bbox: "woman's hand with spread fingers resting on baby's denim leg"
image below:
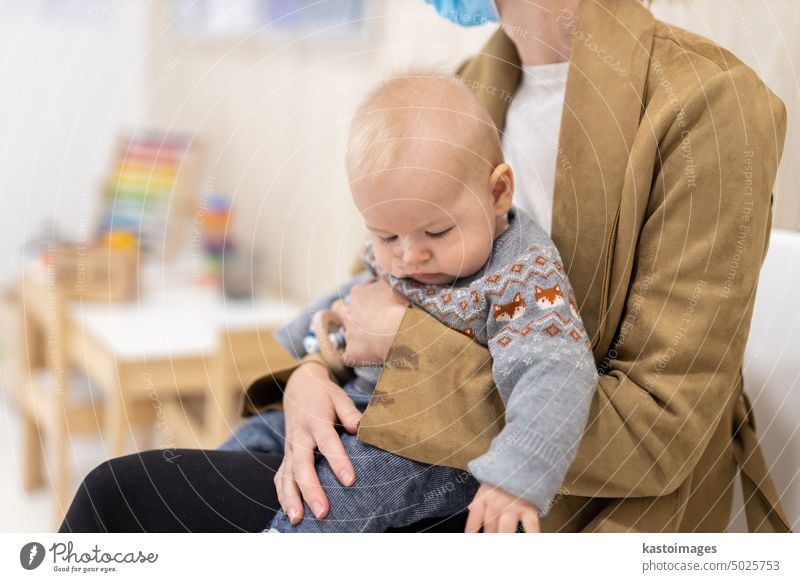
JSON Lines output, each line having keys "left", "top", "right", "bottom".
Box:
{"left": 275, "top": 362, "right": 361, "bottom": 524}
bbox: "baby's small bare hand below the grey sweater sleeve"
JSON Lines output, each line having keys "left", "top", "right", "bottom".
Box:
{"left": 465, "top": 483, "right": 539, "bottom": 533}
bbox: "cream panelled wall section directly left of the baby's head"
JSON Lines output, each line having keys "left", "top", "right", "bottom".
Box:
{"left": 145, "top": 0, "right": 491, "bottom": 299}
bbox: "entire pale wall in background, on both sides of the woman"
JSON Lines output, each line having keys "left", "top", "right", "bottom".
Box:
{"left": 0, "top": 0, "right": 800, "bottom": 299}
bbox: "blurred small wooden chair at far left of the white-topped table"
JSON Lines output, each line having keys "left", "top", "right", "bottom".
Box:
{"left": 16, "top": 276, "right": 153, "bottom": 524}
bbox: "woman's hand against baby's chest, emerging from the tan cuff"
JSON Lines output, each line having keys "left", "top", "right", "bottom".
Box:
{"left": 336, "top": 279, "right": 408, "bottom": 366}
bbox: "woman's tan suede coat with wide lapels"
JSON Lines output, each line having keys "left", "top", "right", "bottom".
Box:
{"left": 245, "top": 0, "right": 789, "bottom": 532}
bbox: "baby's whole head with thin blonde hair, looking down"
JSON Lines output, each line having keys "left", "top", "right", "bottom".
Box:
{"left": 347, "top": 73, "right": 514, "bottom": 284}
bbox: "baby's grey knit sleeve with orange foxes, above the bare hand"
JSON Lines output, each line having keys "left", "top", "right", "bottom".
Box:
{"left": 469, "top": 246, "right": 597, "bottom": 515}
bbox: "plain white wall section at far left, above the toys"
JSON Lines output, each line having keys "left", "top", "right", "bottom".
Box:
{"left": 0, "top": 0, "right": 150, "bottom": 285}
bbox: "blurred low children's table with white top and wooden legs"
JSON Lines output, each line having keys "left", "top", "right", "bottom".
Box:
{"left": 25, "top": 267, "right": 299, "bottom": 455}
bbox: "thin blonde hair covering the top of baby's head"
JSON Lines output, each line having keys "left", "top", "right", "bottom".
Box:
{"left": 347, "top": 69, "right": 503, "bottom": 186}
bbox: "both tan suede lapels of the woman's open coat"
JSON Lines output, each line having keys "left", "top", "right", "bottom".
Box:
{"left": 458, "top": 0, "right": 654, "bottom": 358}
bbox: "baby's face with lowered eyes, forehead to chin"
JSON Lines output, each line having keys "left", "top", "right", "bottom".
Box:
{"left": 351, "top": 155, "right": 510, "bottom": 285}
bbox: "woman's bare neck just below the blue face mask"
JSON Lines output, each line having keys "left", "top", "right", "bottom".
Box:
{"left": 497, "top": 0, "right": 580, "bottom": 66}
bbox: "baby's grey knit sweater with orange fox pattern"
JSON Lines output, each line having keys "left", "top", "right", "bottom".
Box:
{"left": 275, "top": 209, "right": 597, "bottom": 515}
